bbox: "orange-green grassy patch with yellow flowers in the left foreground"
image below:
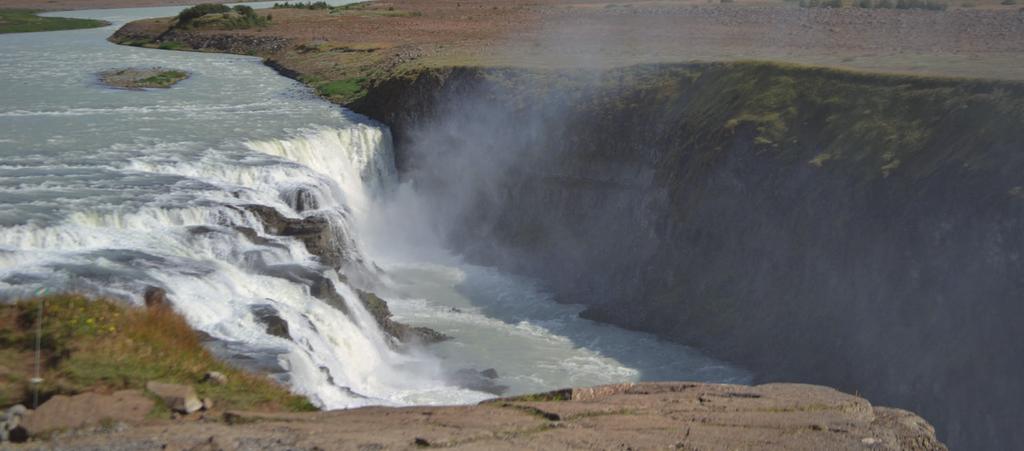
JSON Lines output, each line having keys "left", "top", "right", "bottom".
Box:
{"left": 0, "top": 295, "right": 315, "bottom": 414}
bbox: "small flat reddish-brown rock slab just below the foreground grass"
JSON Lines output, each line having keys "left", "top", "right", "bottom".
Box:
{"left": 22, "top": 390, "right": 154, "bottom": 436}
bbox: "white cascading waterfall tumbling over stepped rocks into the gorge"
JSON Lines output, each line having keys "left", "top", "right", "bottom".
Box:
{"left": 0, "top": 124, "right": 485, "bottom": 409}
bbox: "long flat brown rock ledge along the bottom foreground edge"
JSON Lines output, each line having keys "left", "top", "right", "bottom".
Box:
{"left": 30, "top": 382, "right": 946, "bottom": 450}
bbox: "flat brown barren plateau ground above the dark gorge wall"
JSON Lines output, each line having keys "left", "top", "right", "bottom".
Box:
{"left": 116, "top": 0, "right": 1024, "bottom": 80}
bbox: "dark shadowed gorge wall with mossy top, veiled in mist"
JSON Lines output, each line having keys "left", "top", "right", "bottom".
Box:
{"left": 352, "top": 64, "right": 1024, "bottom": 449}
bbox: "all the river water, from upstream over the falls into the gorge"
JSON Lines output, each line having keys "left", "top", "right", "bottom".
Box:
{"left": 0, "top": 2, "right": 748, "bottom": 408}
